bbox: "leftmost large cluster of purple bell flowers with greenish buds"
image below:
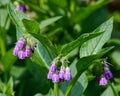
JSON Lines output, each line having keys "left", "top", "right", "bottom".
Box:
{"left": 13, "top": 37, "right": 34, "bottom": 59}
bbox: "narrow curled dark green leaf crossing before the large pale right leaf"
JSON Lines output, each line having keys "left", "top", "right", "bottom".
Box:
{"left": 61, "top": 31, "right": 102, "bottom": 55}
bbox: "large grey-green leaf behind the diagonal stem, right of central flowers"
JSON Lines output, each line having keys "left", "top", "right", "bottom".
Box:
{"left": 60, "top": 59, "right": 88, "bottom": 96}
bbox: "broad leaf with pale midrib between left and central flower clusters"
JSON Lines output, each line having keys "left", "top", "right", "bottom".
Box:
{"left": 31, "top": 42, "right": 55, "bottom": 79}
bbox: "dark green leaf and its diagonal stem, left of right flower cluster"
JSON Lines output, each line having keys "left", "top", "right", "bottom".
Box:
{"left": 65, "top": 47, "right": 113, "bottom": 96}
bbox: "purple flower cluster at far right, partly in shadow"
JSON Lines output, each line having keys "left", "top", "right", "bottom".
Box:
{"left": 97, "top": 64, "right": 113, "bottom": 85}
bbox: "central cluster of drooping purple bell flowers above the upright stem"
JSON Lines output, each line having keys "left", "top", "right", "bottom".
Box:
{"left": 47, "top": 61, "right": 72, "bottom": 83}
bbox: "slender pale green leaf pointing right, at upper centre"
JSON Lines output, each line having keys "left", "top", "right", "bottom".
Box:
{"left": 40, "top": 16, "right": 62, "bottom": 29}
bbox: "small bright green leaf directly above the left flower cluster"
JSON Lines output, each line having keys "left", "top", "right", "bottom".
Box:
{"left": 22, "top": 19, "right": 40, "bottom": 33}
